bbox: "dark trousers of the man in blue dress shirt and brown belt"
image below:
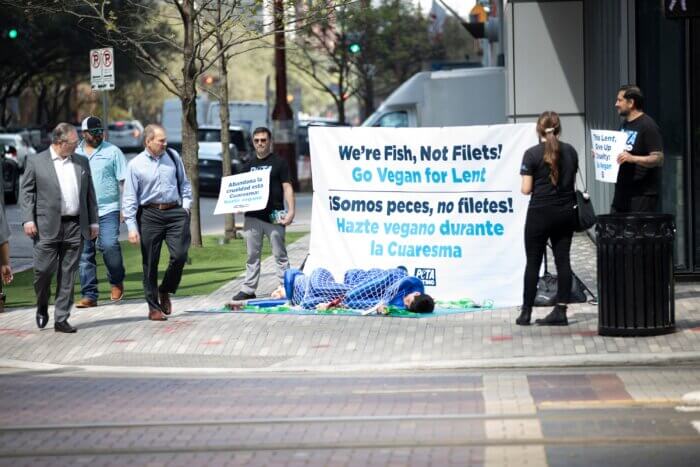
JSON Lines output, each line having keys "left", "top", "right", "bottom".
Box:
{"left": 137, "top": 206, "right": 191, "bottom": 311}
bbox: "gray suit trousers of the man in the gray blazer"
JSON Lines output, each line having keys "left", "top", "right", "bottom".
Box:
{"left": 34, "top": 216, "right": 83, "bottom": 323}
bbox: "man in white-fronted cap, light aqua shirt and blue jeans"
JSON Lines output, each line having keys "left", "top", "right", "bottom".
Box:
{"left": 75, "top": 117, "right": 126, "bottom": 308}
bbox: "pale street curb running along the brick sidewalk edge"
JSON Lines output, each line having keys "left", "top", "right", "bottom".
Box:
{"left": 0, "top": 352, "right": 700, "bottom": 375}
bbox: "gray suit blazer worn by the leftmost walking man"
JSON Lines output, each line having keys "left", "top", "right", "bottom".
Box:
{"left": 20, "top": 149, "right": 99, "bottom": 240}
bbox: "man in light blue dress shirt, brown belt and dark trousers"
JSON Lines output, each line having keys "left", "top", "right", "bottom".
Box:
{"left": 122, "top": 124, "right": 192, "bottom": 321}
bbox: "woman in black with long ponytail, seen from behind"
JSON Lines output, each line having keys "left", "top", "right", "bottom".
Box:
{"left": 515, "top": 111, "right": 578, "bottom": 326}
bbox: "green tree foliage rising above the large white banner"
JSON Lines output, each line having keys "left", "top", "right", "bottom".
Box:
{"left": 290, "top": 0, "right": 445, "bottom": 122}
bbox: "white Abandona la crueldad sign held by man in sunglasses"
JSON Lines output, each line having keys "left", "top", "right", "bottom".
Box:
{"left": 214, "top": 167, "right": 270, "bottom": 214}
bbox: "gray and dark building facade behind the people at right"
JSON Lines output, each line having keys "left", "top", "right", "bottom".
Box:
{"left": 503, "top": 0, "right": 700, "bottom": 278}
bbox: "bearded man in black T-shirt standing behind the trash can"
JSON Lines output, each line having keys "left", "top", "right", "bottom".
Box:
{"left": 611, "top": 85, "right": 664, "bottom": 213}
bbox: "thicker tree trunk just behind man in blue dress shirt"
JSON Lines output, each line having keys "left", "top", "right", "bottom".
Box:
{"left": 182, "top": 0, "right": 202, "bottom": 247}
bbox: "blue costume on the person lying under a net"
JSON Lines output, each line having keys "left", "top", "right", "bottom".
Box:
{"left": 284, "top": 267, "right": 425, "bottom": 310}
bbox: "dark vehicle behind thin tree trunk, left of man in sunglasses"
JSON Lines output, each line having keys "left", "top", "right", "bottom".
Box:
{"left": 197, "top": 125, "right": 253, "bottom": 194}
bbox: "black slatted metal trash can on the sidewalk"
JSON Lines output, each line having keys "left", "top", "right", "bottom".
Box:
{"left": 596, "top": 213, "right": 676, "bottom": 336}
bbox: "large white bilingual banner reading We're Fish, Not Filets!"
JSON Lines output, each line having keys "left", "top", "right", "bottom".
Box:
{"left": 305, "top": 123, "right": 537, "bottom": 307}
